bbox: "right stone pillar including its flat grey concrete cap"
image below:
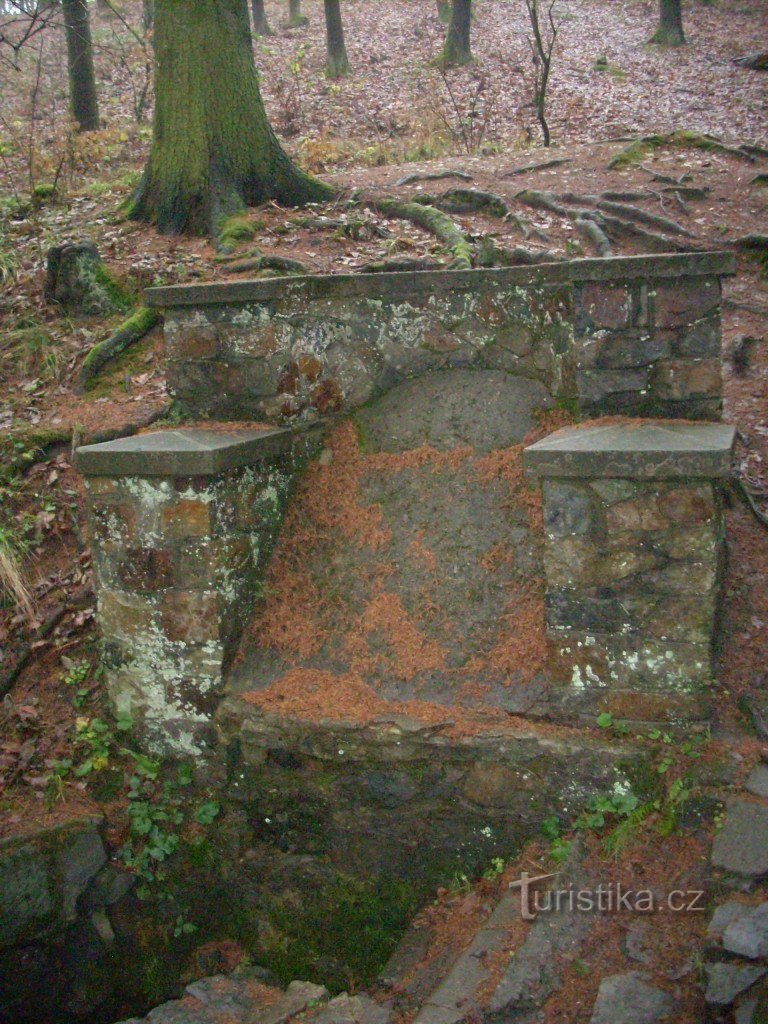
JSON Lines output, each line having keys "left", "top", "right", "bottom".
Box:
{"left": 524, "top": 420, "right": 734, "bottom": 724}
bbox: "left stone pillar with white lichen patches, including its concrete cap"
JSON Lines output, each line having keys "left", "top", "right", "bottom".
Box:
{"left": 78, "top": 429, "right": 321, "bottom": 755}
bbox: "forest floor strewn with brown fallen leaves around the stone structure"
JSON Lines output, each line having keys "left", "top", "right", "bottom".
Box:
{"left": 0, "top": 0, "right": 768, "bottom": 1020}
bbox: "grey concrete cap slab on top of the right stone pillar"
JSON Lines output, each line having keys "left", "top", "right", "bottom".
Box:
{"left": 523, "top": 420, "right": 736, "bottom": 480}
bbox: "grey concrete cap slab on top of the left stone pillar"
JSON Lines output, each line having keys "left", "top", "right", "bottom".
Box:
{"left": 75, "top": 427, "right": 307, "bottom": 477}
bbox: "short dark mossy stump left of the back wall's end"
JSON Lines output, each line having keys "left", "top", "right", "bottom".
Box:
{"left": 45, "top": 241, "right": 127, "bottom": 316}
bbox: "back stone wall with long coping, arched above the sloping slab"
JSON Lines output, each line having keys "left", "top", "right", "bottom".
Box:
{"left": 146, "top": 253, "right": 734, "bottom": 421}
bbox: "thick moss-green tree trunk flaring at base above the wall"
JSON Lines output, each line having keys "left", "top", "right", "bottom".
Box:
{"left": 127, "top": 0, "right": 333, "bottom": 234}
